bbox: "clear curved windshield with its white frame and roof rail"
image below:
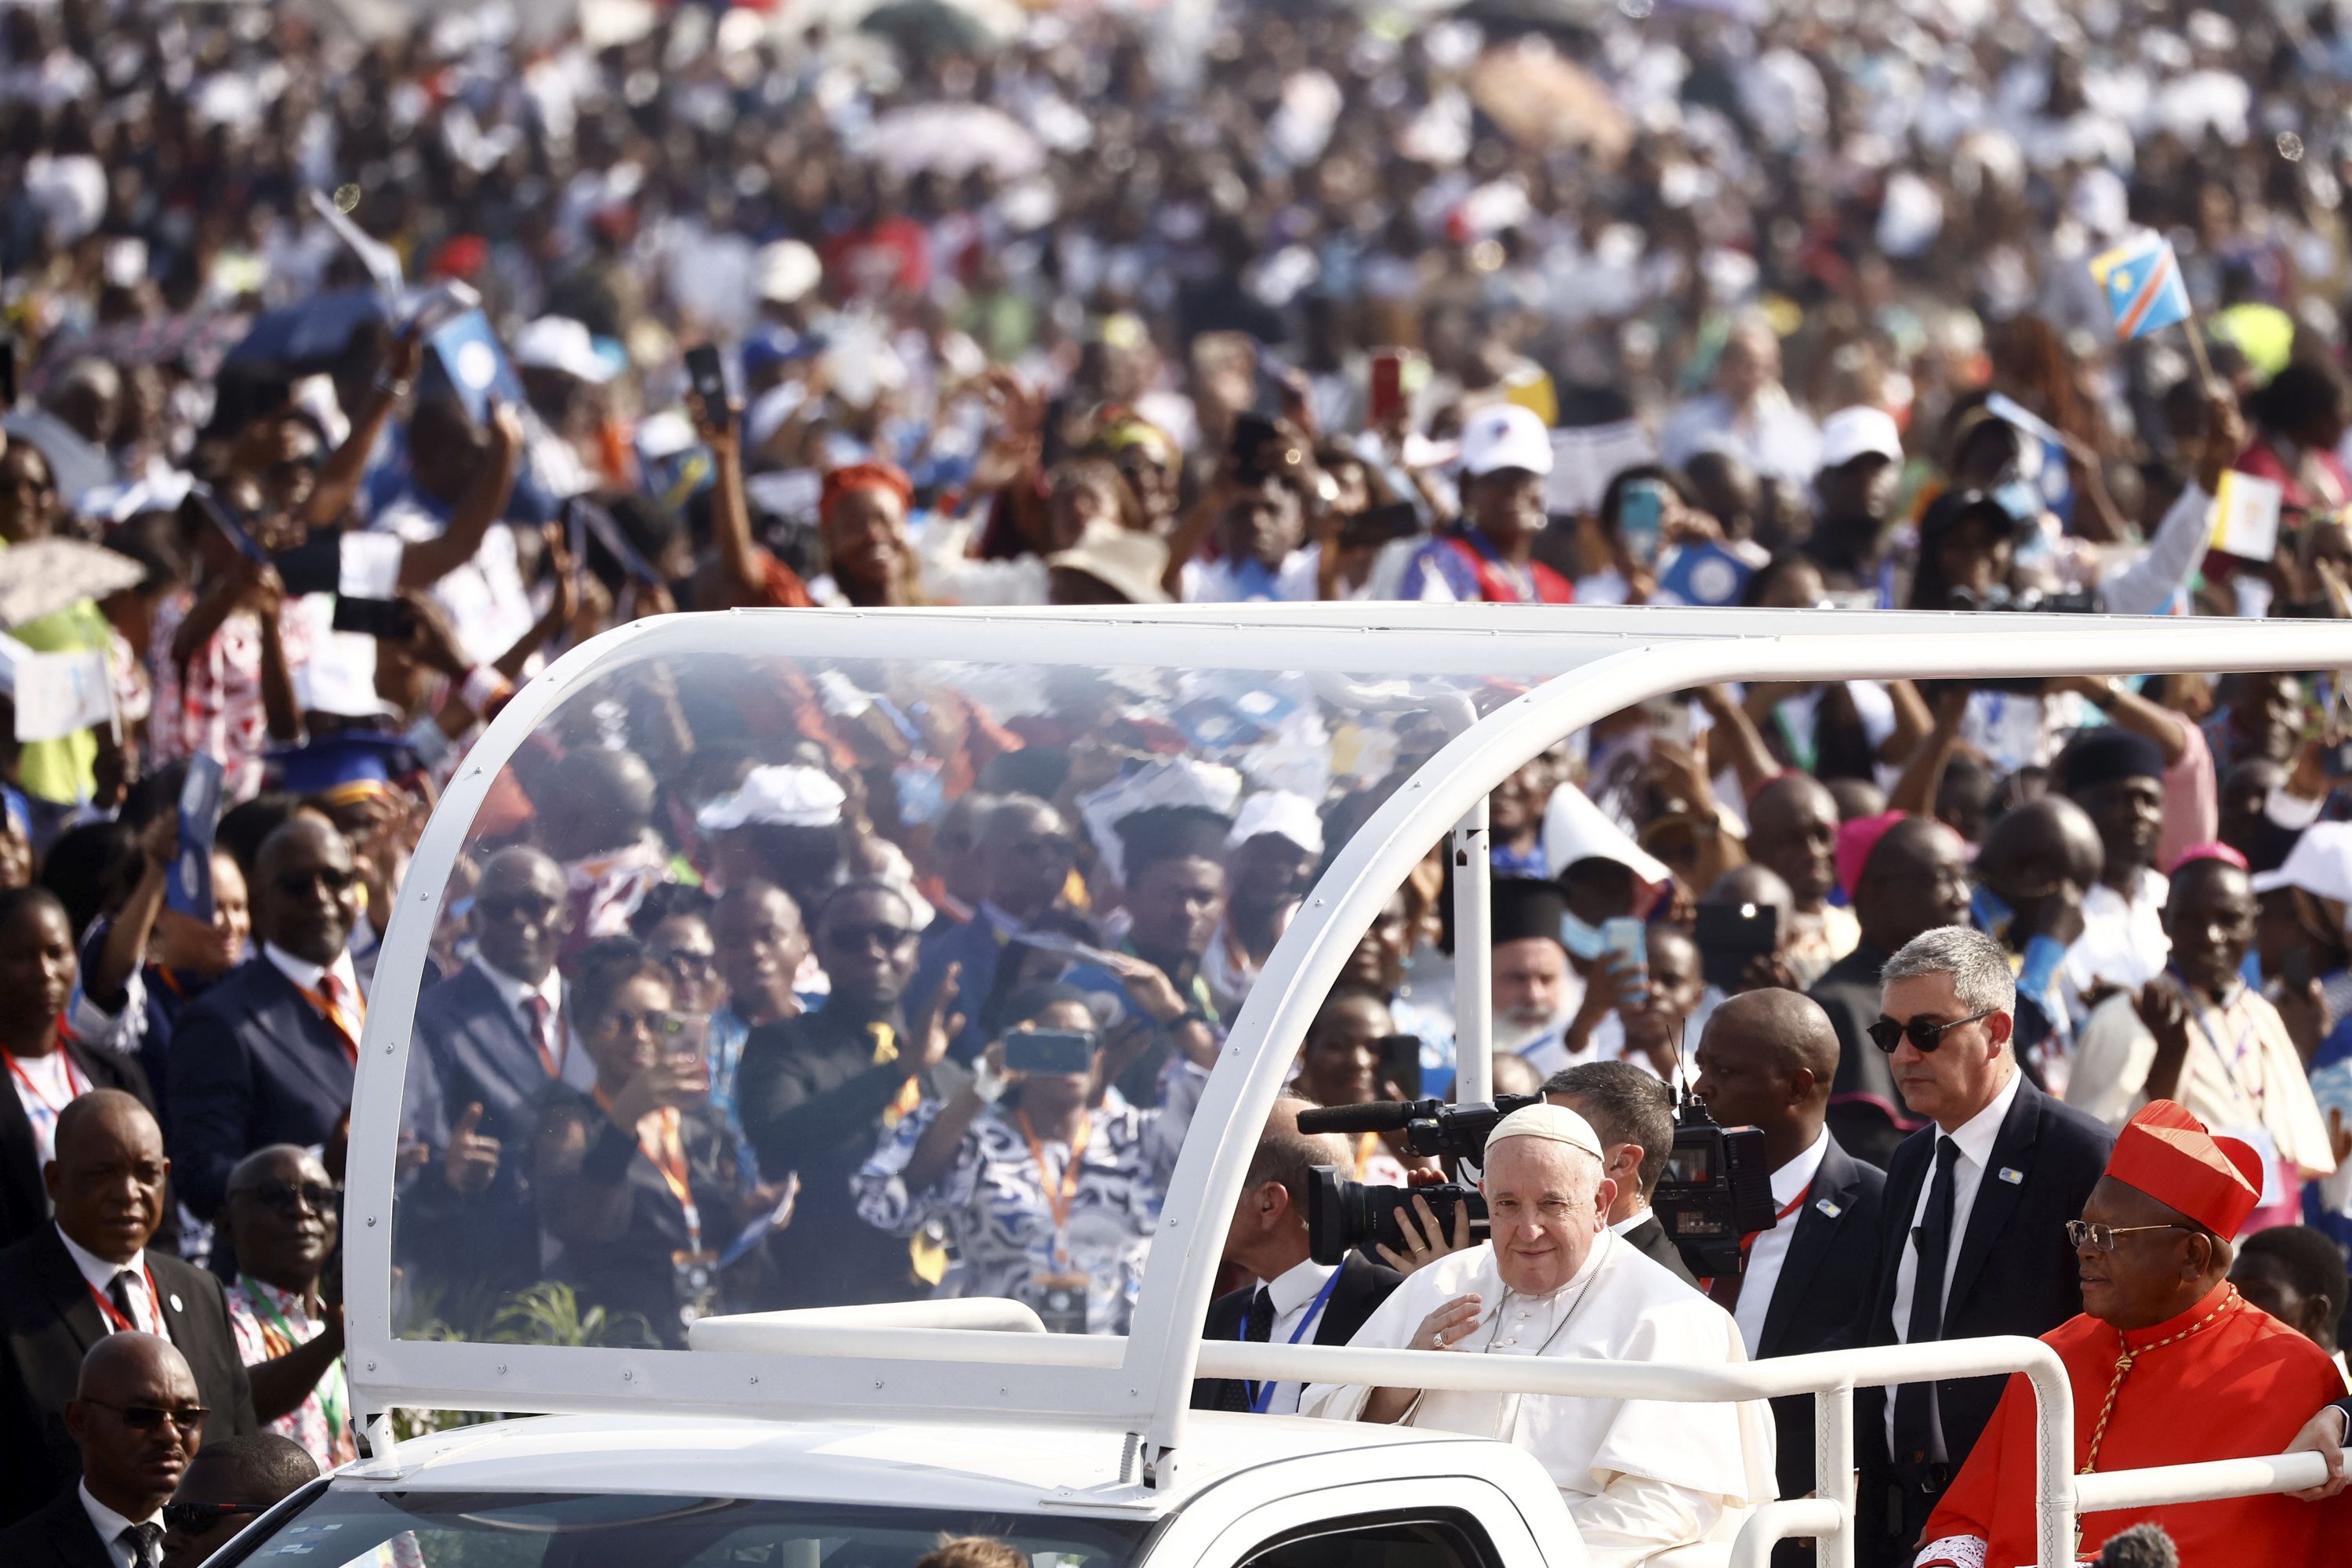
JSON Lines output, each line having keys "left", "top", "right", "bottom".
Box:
{"left": 343, "top": 604, "right": 2352, "bottom": 1446}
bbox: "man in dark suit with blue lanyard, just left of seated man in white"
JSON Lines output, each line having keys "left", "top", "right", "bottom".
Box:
{"left": 1192, "top": 1100, "right": 1404, "bottom": 1415}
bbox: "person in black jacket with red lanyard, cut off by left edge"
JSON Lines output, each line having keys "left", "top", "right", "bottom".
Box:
{"left": 0, "top": 886, "right": 169, "bottom": 1246}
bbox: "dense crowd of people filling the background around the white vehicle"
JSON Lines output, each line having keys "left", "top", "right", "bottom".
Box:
{"left": 0, "top": 0, "right": 2352, "bottom": 1566}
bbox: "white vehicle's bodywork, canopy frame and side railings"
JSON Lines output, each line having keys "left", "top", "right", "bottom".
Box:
{"left": 214, "top": 604, "right": 2352, "bottom": 1568}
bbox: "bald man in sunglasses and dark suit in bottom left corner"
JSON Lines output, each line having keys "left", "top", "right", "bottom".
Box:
{"left": 0, "top": 1333, "right": 207, "bottom": 1568}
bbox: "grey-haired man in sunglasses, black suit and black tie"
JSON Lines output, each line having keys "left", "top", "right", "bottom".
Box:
{"left": 1853, "top": 926, "right": 2114, "bottom": 1566}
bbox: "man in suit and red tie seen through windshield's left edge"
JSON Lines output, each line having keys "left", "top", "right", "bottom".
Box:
{"left": 400, "top": 846, "right": 576, "bottom": 1286}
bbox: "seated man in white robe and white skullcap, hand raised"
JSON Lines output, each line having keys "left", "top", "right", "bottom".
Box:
{"left": 1298, "top": 1105, "right": 1773, "bottom": 1568}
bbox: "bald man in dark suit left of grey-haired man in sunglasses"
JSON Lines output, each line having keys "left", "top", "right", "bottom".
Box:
{"left": 1691, "top": 989, "right": 1886, "bottom": 1568}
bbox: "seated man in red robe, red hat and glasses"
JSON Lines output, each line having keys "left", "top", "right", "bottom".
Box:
{"left": 1915, "top": 1100, "right": 2352, "bottom": 1568}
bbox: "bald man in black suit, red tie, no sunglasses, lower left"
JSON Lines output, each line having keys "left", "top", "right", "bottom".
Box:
{"left": 0, "top": 1088, "right": 254, "bottom": 1521}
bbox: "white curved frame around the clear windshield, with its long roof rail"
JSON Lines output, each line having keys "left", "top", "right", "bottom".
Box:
{"left": 346, "top": 604, "right": 2352, "bottom": 1542}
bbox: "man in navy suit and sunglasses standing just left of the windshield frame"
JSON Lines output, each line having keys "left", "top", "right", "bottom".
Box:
{"left": 169, "top": 811, "right": 365, "bottom": 1220}
